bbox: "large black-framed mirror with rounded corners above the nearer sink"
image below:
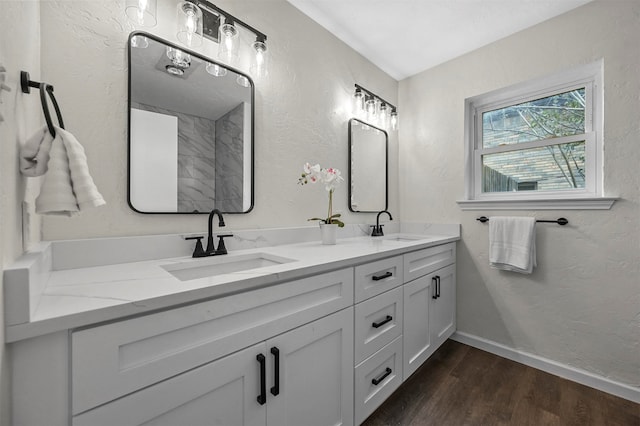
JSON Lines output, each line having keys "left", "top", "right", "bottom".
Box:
{"left": 128, "top": 32, "right": 254, "bottom": 213}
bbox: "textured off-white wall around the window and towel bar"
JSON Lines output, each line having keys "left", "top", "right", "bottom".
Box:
{"left": 399, "top": 1, "right": 640, "bottom": 386}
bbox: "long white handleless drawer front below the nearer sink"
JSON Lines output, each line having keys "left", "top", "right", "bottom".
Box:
{"left": 71, "top": 268, "right": 353, "bottom": 414}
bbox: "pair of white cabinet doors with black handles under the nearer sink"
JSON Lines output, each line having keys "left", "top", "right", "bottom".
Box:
{"left": 73, "top": 308, "right": 353, "bottom": 426}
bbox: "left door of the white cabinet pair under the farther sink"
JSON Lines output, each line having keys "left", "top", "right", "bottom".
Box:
{"left": 403, "top": 275, "right": 435, "bottom": 380}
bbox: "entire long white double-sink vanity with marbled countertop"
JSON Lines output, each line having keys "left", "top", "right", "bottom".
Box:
{"left": 5, "top": 226, "right": 459, "bottom": 426}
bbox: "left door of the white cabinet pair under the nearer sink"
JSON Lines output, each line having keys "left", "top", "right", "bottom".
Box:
{"left": 72, "top": 342, "right": 266, "bottom": 426}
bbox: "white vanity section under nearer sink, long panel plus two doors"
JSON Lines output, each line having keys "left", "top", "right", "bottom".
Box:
{"left": 71, "top": 268, "right": 353, "bottom": 426}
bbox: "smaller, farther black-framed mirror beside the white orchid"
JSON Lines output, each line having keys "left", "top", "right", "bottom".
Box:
{"left": 349, "top": 118, "right": 389, "bottom": 213}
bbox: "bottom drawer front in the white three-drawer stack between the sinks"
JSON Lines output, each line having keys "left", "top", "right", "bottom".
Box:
{"left": 355, "top": 336, "right": 402, "bottom": 425}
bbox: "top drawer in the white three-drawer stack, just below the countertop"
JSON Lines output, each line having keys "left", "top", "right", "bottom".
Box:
{"left": 355, "top": 256, "right": 403, "bottom": 303}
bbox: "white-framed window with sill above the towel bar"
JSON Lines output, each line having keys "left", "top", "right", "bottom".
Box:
{"left": 459, "top": 62, "right": 612, "bottom": 209}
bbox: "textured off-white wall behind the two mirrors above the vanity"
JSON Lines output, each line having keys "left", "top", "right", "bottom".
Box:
{"left": 42, "top": 0, "right": 398, "bottom": 240}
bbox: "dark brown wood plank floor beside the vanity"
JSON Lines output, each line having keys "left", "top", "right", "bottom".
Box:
{"left": 363, "top": 340, "right": 640, "bottom": 426}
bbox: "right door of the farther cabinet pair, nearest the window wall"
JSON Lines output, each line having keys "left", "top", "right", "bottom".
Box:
{"left": 431, "top": 265, "right": 456, "bottom": 348}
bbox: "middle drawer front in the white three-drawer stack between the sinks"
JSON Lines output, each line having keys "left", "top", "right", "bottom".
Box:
{"left": 355, "top": 287, "right": 403, "bottom": 364}
